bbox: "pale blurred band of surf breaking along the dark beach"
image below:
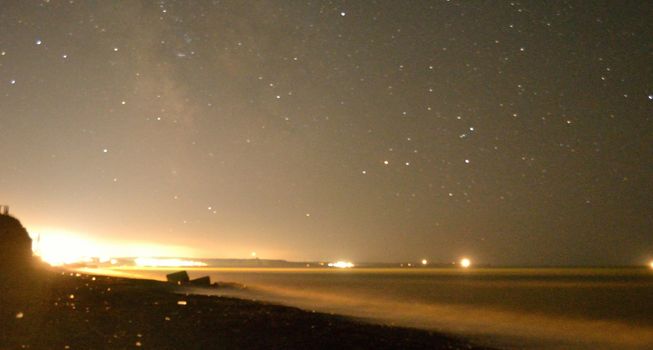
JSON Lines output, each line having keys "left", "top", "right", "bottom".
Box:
{"left": 194, "top": 284, "right": 653, "bottom": 349}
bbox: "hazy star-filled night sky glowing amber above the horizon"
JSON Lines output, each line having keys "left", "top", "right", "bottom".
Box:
{"left": 0, "top": 0, "right": 653, "bottom": 265}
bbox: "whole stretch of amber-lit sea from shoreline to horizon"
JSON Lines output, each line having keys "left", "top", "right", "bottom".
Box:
{"left": 91, "top": 268, "right": 653, "bottom": 349}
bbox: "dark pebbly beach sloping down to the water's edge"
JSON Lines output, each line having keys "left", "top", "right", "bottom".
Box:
{"left": 0, "top": 272, "right": 488, "bottom": 349}
